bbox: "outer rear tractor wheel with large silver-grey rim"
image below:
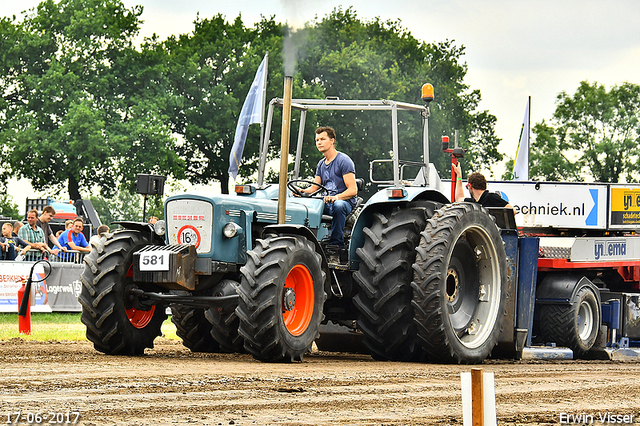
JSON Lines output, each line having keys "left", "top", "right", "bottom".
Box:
{"left": 411, "top": 203, "right": 507, "bottom": 364}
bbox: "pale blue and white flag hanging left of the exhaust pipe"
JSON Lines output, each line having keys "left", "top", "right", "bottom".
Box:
{"left": 229, "top": 53, "right": 269, "bottom": 180}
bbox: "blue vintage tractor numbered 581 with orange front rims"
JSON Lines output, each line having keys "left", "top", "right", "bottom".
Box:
{"left": 80, "top": 90, "right": 510, "bottom": 363}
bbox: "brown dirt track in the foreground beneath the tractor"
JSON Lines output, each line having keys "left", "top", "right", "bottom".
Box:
{"left": 0, "top": 338, "right": 640, "bottom": 425}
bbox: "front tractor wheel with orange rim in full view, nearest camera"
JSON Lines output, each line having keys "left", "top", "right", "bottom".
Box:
{"left": 236, "top": 235, "right": 326, "bottom": 362}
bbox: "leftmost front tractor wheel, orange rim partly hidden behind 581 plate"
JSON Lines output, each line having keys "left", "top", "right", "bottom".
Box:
{"left": 78, "top": 229, "right": 167, "bottom": 355}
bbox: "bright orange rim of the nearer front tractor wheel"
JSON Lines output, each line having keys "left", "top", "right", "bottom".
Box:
{"left": 282, "top": 265, "right": 315, "bottom": 336}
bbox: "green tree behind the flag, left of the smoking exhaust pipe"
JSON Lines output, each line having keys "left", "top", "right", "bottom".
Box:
{"left": 162, "top": 15, "right": 318, "bottom": 192}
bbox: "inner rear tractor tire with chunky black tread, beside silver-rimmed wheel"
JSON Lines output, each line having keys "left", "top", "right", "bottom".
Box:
{"left": 354, "top": 202, "right": 440, "bottom": 361}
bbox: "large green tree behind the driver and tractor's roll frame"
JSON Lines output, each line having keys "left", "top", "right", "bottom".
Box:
{"left": 296, "top": 8, "right": 502, "bottom": 189}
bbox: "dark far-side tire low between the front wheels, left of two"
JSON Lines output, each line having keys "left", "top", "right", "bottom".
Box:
{"left": 171, "top": 306, "right": 220, "bottom": 353}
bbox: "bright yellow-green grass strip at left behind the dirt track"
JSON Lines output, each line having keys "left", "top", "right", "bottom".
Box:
{"left": 0, "top": 312, "right": 180, "bottom": 342}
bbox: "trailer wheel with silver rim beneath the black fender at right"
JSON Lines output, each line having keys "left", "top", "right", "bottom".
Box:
{"left": 540, "top": 286, "right": 601, "bottom": 358}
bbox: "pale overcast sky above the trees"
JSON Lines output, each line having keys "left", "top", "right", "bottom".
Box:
{"left": 0, "top": 0, "right": 640, "bottom": 206}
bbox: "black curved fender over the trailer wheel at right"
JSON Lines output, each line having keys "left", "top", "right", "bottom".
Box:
{"left": 536, "top": 274, "right": 600, "bottom": 305}
